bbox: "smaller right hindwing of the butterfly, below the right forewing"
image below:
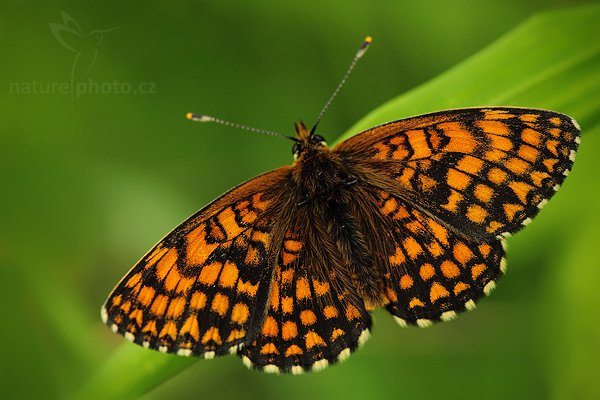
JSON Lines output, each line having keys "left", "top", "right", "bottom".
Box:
{"left": 378, "top": 192, "right": 506, "bottom": 327}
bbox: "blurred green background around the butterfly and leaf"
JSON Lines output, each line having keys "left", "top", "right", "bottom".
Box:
{"left": 0, "top": 0, "right": 600, "bottom": 399}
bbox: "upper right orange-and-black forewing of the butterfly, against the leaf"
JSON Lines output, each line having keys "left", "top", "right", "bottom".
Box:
{"left": 335, "top": 107, "right": 580, "bottom": 240}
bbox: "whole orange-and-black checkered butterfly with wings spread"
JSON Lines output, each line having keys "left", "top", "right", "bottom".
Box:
{"left": 102, "top": 38, "right": 580, "bottom": 374}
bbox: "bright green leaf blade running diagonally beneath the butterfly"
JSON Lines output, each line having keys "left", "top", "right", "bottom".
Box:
{"left": 79, "top": 4, "right": 600, "bottom": 399}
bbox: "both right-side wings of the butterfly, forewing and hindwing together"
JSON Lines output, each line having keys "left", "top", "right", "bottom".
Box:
{"left": 335, "top": 108, "right": 580, "bottom": 326}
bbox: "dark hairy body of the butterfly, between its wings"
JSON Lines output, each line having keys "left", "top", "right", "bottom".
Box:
{"left": 290, "top": 124, "right": 392, "bottom": 309}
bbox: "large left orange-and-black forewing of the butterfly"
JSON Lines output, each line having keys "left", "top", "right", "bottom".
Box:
{"left": 102, "top": 167, "right": 291, "bottom": 358}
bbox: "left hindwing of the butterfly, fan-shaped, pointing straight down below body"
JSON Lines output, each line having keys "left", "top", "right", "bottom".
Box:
{"left": 238, "top": 207, "right": 371, "bottom": 374}
